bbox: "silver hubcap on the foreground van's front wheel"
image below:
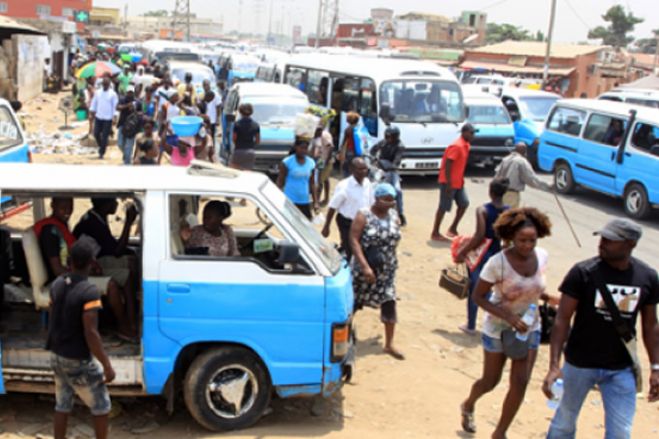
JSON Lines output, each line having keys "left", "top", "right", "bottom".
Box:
{"left": 206, "top": 364, "right": 259, "bottom": 419}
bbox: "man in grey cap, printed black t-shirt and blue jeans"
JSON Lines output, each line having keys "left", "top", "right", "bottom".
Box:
{"left": 543, "top": 219, "right": 659, "bottom": 439}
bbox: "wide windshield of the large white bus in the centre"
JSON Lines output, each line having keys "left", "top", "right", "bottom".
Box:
{"left": 380, "top": 79, "right": 465, "bottom": 123}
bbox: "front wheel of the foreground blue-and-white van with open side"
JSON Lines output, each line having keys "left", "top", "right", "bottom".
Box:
{"left": 183, "top": 347, "right": 272, "bottom": 431}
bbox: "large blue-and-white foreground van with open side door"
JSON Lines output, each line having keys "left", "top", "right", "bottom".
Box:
{"left": 0, "top": 162, "right": 353, "bottom": 430}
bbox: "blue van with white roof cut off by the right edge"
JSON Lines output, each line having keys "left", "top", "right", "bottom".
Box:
{"left": 538, "top": 99, "right": 659, "bottom": 219}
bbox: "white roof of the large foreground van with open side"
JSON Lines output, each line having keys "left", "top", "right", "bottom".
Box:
{"left": 0, "top": 161, "right": 268, "bottom": 193}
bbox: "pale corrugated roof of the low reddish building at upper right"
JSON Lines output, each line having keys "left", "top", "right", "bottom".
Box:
{"left": 468, "top": 40, "right": 608, "bottom": 58}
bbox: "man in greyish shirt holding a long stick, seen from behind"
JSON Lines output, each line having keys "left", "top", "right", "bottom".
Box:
{"left": 495, "top": 142, "right": 551, "bottom": 208}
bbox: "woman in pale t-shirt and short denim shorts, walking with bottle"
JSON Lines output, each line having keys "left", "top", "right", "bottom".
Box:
{"left": 460, "top": 208, "right": 551, "bottom": 439}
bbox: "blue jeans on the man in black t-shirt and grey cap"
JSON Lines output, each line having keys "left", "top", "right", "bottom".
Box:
{"left": 547, "top": 362, "right": 636, "bottom": 439}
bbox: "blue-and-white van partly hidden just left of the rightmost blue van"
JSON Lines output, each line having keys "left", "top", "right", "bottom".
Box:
{"left": 501, "top": 87, "right": 561, "bottom": 165}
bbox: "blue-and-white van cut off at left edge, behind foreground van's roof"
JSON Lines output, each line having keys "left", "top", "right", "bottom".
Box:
{"left": 0, "top": 99, "right": 31, "bottom": 216}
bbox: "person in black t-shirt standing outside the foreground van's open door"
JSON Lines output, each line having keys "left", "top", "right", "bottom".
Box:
{"left": 46, "top": 241, "right": 115, "bottom": 439}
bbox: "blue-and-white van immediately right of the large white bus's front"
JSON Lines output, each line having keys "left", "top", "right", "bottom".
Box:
{"left": 463, "top": 88, "right": 515, "bottom": 164}
